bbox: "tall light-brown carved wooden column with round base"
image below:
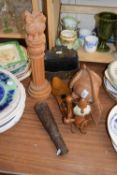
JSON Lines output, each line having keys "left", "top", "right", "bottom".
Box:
{"left": 25, "top": 11, "right": 51, "bottom": 101}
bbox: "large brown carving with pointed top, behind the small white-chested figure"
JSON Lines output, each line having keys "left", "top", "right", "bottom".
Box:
{"left": 70, "top": 65, "right": 102, "bottom": 124}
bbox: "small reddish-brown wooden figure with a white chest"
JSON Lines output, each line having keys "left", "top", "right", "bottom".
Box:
{"left": 64, "top": 90, "right": 92, "bottom": 133}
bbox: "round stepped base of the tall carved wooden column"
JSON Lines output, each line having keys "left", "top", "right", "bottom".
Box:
{"left": 28, "top": 80, "right": 51, "bottom": 101}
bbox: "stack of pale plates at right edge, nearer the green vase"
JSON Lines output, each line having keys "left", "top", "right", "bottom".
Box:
{"left": 104, "top": 61, "right": 117, "bottom": 100}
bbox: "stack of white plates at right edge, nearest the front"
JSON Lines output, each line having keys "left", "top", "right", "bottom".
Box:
{"left": 107, "top": 105, "right": 117, "bottom": 152}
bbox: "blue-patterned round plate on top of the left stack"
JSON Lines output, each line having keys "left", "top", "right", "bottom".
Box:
{"left": 0, "top": 69, "right": 24, "bottom": 120}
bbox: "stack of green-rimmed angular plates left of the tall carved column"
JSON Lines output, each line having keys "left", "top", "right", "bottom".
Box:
{"left": 0, "top": 41, "right": 31, "bottom": 81}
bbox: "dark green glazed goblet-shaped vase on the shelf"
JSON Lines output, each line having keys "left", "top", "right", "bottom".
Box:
{"left": 95, "top": 12, "right": 117, "bottom": 52}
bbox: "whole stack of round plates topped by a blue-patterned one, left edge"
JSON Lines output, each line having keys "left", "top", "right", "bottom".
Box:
{"left": 0, "top": 69, "right": 26, "bottom": 133}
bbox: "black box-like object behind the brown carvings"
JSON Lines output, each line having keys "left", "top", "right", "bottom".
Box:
{"left": 45, "top": 46, "right": 80, "bottom": 79}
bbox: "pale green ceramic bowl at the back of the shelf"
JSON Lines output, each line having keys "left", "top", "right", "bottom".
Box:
{"left": 61, "top": 16, "right": 79, "bottom": 30}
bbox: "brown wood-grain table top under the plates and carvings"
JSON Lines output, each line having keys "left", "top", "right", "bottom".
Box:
{"left": 0, "top": 63, "right": 117, "bottom": 175}
